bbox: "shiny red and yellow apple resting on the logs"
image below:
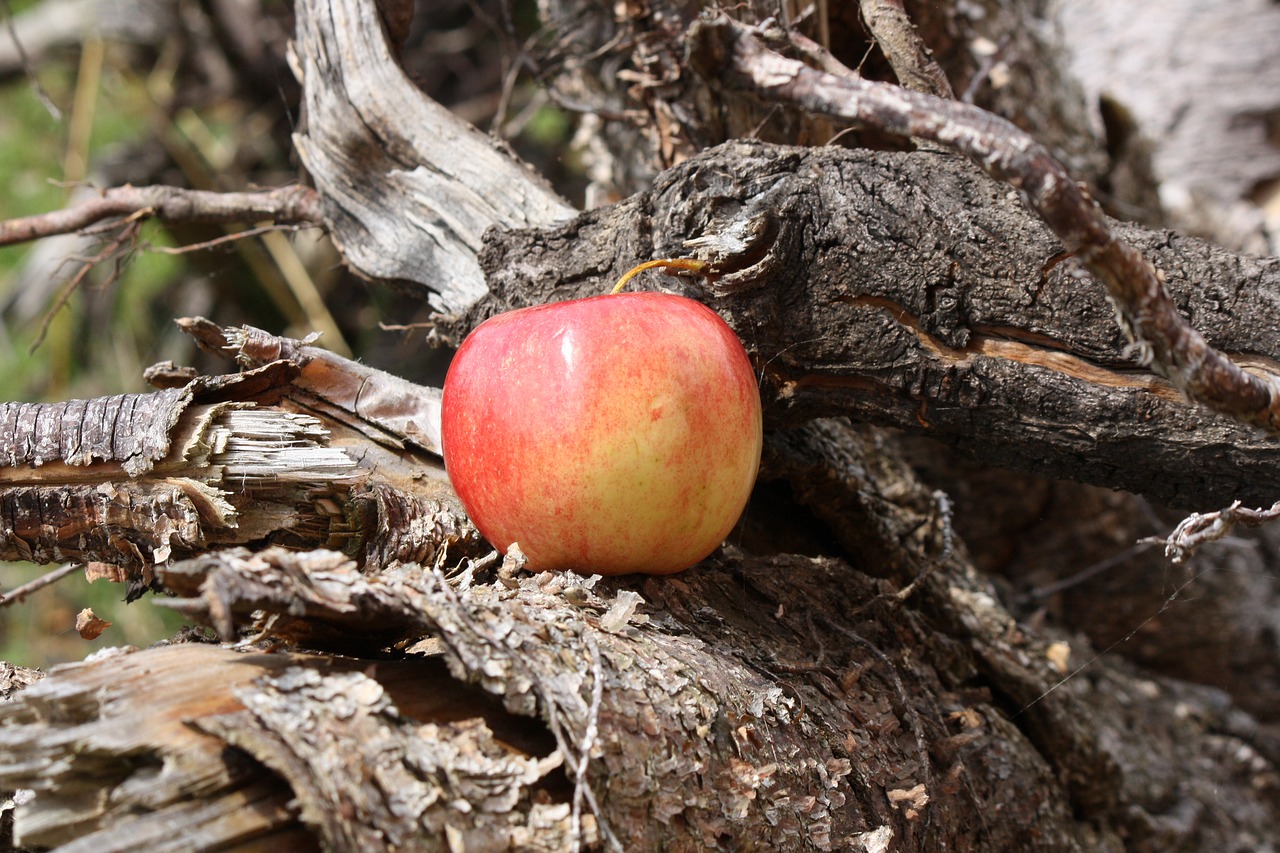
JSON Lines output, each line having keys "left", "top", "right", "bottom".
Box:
{"left": 440, "top": 292, "right": 762, "bottom": 575}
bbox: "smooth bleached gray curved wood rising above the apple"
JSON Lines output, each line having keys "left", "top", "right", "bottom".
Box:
{"left": 294, "top": 0, "right": 573, "bottom": 313}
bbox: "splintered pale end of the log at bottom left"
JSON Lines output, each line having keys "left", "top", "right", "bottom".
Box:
{"left": 0, "top": 644, "right": 568, "bottom": 852}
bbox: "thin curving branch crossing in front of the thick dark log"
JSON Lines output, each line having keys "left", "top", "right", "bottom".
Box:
{"left": 690, "top": 17, "right": 1280, "bottom": 432}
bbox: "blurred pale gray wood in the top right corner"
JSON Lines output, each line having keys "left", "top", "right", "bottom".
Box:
{"left": 1050, "top": 0, "right": 1280, "bottom": 252}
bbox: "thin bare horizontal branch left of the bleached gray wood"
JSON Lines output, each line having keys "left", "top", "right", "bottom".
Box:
{"left": 0, "top": 180, "right": 323, "bottom": 246}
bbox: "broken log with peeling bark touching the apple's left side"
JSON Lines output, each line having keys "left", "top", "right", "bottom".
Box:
{"left": 0, "top": 320, "right": 479, "bottom": 578}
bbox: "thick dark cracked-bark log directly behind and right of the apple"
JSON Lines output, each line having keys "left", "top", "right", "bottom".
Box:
{"left": 463, "top": 142, "right": 1280, "bottom": 507}
